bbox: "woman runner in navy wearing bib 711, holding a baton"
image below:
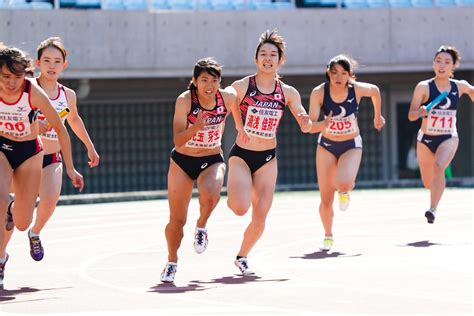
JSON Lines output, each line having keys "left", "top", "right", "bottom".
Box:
{"left": 408, "top": 46, "right": 474, "bottom": 224}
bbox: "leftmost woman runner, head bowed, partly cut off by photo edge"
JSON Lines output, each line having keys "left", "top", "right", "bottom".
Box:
{"left": 0, "top": 47, "right": 84, "bottom": 287}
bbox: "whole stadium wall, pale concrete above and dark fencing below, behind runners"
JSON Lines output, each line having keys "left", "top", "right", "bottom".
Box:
{"left": 0, "top": 8, "right": 474, "bottom": 194}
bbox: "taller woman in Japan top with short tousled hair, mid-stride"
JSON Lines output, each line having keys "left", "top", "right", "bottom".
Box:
{"left": 227, "top": 31, "right": 311, "bottom": 275}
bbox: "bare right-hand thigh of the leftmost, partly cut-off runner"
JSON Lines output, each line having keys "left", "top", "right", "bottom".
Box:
{"left": 13, "top": 152, "right": 43, "bottom": 219}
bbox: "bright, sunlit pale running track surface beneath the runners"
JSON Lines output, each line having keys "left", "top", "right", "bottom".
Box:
{"left": 0, "top": 189, "right": 474, "bottom": 316}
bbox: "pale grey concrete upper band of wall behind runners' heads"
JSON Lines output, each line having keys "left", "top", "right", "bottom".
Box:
{"left": 0, "top": 7, "right": 474, "bottom": 78}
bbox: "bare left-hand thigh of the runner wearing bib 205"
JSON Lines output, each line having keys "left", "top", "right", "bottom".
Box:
{"left": 316, "top": 145, "right": 337, "bottom": 200}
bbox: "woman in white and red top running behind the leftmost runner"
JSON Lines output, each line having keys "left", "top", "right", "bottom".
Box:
{"left": 23, "top": 37, "right": 99, "bottom": 261}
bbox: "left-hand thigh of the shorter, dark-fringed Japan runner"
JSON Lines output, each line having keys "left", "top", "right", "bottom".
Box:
{"left": 168, "top": 159, "right": 194, "bottom": 219}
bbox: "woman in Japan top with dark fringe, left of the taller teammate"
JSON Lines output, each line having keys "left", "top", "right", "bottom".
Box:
{"left": 161, "top": 58, "right": 235, "bottom": 282}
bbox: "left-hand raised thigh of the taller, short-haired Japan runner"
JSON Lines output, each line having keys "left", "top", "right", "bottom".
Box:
{"left": 227, "top": 156, "right": 252, "bottom": 208}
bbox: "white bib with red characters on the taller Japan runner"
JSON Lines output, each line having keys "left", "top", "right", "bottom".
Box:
{"left": 244, "top": 106, "right": 283, "bottom": 139}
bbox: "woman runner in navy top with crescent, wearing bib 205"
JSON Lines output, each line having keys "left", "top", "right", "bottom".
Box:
{"left": 309, "top": 55, "right": 385, "bottom": 251}
